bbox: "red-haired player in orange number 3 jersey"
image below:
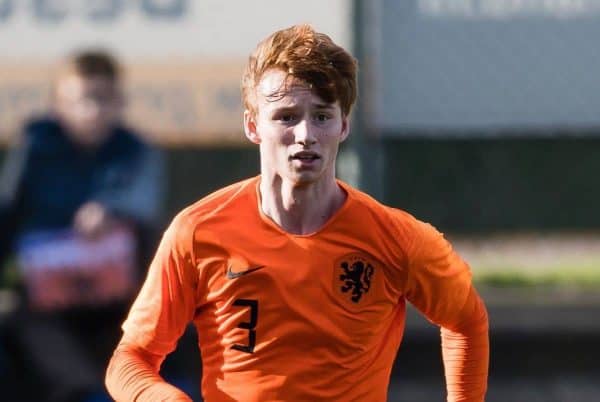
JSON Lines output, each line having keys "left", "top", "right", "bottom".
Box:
{"left": 106, "top": 26, "right": 488, "bottom": 402}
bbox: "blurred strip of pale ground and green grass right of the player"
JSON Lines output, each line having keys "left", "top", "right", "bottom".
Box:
{"left": 448, "top": 233, "right": 600, "bottom": 291}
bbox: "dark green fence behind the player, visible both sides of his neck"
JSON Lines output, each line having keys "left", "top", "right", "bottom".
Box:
{"left": 2, "top": 137, "right": 600, "bottom": 232}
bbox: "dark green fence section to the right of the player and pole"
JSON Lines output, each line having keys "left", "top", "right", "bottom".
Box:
{"left": 382, "top": 138, "right": 600, "bottom": 232}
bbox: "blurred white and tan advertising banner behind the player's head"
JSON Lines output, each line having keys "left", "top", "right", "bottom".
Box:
{"left": 0, "top": 0, "right": 351, "bottom": 145}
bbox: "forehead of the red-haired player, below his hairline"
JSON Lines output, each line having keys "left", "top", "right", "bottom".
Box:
{"left": 256, "top": 69, "right": 337, "bottom": 110}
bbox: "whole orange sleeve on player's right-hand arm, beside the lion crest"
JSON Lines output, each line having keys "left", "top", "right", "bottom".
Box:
{"left": 405, "top": 221, "right": 489, "bottom": 402}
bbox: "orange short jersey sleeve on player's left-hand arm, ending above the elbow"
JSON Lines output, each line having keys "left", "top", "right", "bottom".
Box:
{"left": 123, "top": 215, "right": 198, "bottom": 356}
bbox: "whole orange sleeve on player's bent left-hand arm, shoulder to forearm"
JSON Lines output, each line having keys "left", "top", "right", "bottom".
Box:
{"left": 105, "top": 212, "right": 197, "bottom": 402}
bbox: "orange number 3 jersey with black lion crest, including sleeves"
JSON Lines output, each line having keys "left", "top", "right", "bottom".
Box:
{"left": 107, "top": 178, "right": 488, "bottom": 402}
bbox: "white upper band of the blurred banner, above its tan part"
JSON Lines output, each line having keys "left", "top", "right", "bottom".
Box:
{"left": 0, "top": 0, "right": 352, "bottom": 61}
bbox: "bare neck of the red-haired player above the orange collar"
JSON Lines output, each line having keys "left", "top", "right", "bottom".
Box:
{"left": 260, "top": 174, "right": 346, "bottom": 234}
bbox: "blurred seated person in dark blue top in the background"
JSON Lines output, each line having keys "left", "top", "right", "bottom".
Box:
{"left": 0, "top": 50, "right": 163, "bottom": 401}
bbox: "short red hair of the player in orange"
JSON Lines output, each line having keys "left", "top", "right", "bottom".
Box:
{"left": 242, "top": 25, "right": 358, "bottom": 116}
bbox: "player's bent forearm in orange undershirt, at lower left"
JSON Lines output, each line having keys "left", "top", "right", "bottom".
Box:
{"left": 106, "top": 343, "right": 192, "bottom": 402}
